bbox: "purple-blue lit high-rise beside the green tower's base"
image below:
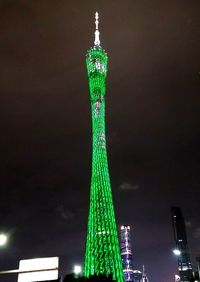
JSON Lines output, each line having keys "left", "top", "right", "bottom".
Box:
{"left": 120, "top": 225, "right": 134, "bottom": 281}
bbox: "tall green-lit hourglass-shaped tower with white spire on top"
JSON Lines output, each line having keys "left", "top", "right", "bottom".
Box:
{"left": 84, "top": 13, "right": 124, "bottom": 282}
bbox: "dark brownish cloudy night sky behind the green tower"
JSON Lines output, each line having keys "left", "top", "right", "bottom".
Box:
{"left": 0, "top": 0, "right": 200, "bottom": 282}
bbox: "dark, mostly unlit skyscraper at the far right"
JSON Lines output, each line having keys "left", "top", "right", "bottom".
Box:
{"left": 171, "top": 207, "right": 192, "bottom": 282}
